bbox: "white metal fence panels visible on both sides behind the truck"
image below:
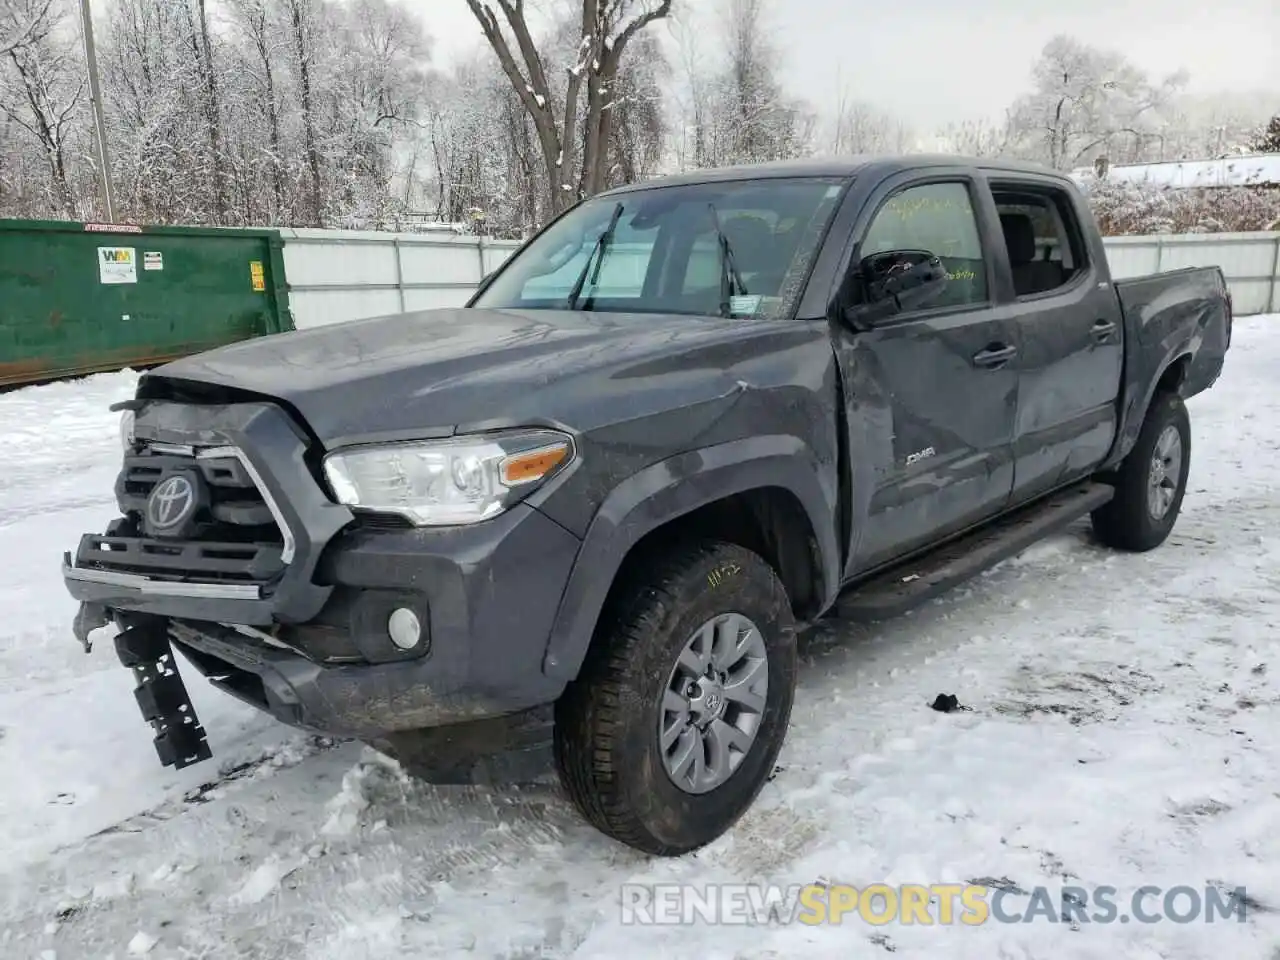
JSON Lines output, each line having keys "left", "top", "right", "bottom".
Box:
{"left": 280, "top": 230, "right": 1280, "bottom": 328}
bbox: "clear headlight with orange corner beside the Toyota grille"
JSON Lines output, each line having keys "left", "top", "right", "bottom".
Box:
{"left": 324, "top": 430, "right": 575, "bottom": 526}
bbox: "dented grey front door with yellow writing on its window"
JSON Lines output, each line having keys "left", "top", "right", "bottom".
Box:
{"left": 836, "top": 170, "right": 1018, "bottom": 576}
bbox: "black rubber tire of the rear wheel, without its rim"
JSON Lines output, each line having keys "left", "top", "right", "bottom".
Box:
{"left": 1092, "top": 393, "right": 1192, "bottom": 553}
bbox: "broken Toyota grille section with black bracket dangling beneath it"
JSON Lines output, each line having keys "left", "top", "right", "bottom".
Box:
{"left": 63, "top": 386, "right": 351, "bottom": 769}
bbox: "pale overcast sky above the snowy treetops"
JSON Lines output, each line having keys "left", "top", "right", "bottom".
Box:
{"left": 406, "top": 0, "right": 1280, "bottom": 129}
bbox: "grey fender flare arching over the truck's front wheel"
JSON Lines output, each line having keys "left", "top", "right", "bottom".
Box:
{"left": 543, "top": 435, "right": 841, "bottom": 682}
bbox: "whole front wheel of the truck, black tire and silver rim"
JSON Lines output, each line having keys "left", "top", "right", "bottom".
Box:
{"left": 554, "top": 543, "right": 796, "bottom": 856}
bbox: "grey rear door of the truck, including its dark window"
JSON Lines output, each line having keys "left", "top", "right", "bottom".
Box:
{"left": 991, "top": 173, "right": 1124, "bottom": 502}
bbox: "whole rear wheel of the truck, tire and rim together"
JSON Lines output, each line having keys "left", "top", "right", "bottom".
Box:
{"left": 1092, "top": 393, "right": 1192, "bottom": 552}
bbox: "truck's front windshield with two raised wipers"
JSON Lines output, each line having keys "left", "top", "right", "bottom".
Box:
{"left": 472, "top": 177, "right": 846, "bottom": 317}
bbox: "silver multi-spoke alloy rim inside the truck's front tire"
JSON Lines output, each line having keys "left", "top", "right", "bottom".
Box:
{"left": 658, "top": 613, "right": 769, "bottom": 794}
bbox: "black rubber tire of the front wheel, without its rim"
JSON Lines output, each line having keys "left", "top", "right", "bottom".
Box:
{"left": 554, "top": 543, "right": 796, "bottom": 856}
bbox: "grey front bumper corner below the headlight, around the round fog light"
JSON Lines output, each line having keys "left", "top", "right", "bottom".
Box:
{"left": 162, "top": 504, "right": 579, "bottom": 740}
